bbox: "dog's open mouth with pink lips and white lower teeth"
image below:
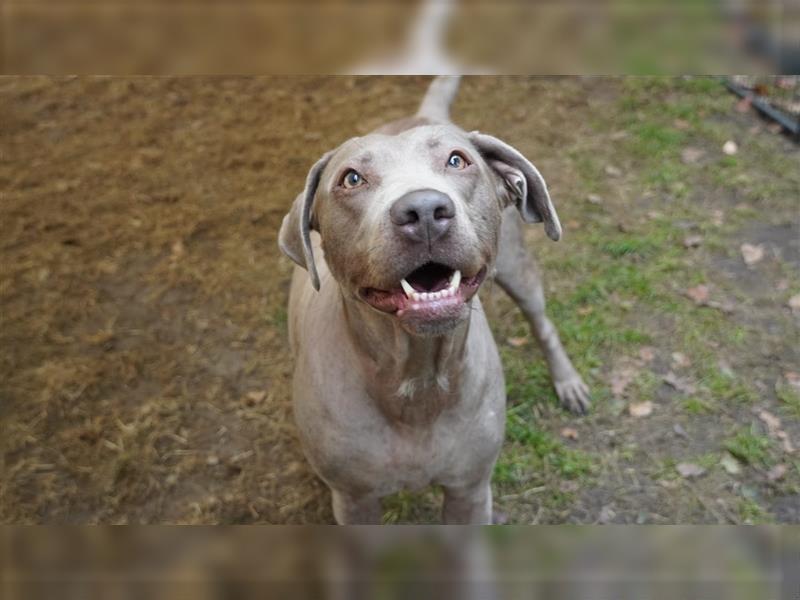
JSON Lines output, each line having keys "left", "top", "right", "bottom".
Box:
{"left": 361, "top": 262, "right": 486, "bottom": 319}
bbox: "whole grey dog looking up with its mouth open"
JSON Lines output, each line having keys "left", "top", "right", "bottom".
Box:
{"left": 279, "top": 78, "right": 589, "bottom": 524}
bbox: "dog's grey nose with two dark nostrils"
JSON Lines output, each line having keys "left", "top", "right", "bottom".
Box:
{"left": 389, "top": 190, "right": 456, "bottom": 244}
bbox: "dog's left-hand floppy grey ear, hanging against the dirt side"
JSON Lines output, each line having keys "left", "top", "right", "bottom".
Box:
{"left": 278, "top": 151, "right": 333, "bottom": 290}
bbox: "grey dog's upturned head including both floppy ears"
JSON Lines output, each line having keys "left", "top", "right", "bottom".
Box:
{"left": 279, "top": 125, "right": 561, "bottom": 335}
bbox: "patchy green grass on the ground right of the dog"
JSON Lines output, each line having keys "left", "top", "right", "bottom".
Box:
{"left": 495, "top": 78, "right": 800, "bottom": 522}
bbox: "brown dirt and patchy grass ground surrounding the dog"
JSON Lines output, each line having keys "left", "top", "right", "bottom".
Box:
{"left": 0, "top": 77, "right": 800, "bottom": 523}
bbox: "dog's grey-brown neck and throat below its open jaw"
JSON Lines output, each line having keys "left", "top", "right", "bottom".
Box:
{"left": 342, "top": 292, "right": 470, "bottom": 425}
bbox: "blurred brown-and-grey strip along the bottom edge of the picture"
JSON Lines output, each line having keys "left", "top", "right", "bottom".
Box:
{"left": 0, "top": 526, "right": 800, "bottom": 600}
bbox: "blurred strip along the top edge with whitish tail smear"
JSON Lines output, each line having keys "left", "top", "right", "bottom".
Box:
{"left": 0, "top": 0, "right": 800, "bottom": 74}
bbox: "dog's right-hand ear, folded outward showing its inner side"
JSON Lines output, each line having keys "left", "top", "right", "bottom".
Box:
{"left": 469, "top": 131, "right": 561, "bottom": 240}
